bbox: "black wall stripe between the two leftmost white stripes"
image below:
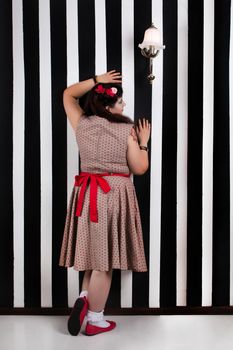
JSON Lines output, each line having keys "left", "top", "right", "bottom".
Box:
{"left": 23, "top": 0, "right": 41, "bottom": 307}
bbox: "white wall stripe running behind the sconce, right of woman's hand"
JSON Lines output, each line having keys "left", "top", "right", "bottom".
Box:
{"left": 150, "top": 0, "right": 163, "bottom": 307}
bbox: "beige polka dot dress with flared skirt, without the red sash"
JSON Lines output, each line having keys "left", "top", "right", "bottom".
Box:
{"left": 59, "top": 116, "right": 147, "bottom": 272}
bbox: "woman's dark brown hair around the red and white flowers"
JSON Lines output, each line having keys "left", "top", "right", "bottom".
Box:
{"left": 83, "top": 83, "right": 135, "bottom": 125}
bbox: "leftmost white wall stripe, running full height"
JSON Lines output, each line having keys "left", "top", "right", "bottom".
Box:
{"left": 12, "top": 0, "right": 25, "bottom": 307}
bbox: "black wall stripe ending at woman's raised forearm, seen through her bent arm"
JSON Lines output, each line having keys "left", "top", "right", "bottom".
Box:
{"left": 78, "top": 0, "right": 95, "bottom": 292}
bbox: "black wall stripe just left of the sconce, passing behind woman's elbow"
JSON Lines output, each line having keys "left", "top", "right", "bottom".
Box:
{"left": 133, "top": 0, "right": 152, "bottom": 307}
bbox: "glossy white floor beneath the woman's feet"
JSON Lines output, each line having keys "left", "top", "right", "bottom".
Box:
{"left": 0, "top": 315, "right": 233, "bottom": 350}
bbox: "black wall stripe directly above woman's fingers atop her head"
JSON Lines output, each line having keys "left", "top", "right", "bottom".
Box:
{"left": 105, "top": 0, "right": 122, "bottom": 307}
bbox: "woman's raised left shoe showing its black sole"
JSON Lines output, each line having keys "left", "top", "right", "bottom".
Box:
{"left": 68, "top": 296, "right": 88, "bottom": 335}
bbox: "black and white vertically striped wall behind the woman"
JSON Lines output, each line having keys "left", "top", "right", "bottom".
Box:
{"left": 0, "top": 0, "right": 233, "bottom": 312}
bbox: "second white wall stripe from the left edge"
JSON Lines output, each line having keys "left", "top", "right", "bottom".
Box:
{"left": 39, "top": 0, "right": 52, "bottom": 307}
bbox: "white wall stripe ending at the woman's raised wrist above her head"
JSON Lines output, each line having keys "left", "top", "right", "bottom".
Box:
{"left": 95, "top": 0, "right": 107, "bottom": 75}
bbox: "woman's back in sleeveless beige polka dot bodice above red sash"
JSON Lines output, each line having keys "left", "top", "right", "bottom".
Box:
{"left": 75, "top": 115, "right": 133, "bottom": 173}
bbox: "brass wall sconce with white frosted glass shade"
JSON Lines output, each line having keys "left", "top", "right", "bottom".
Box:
{"left": 138, "top": 23, "right": 165, "bottom": 84}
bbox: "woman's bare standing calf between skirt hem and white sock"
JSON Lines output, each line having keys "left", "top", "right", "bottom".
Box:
{"left": 88, "top": 270, "right": 112, "bottom": 312}
